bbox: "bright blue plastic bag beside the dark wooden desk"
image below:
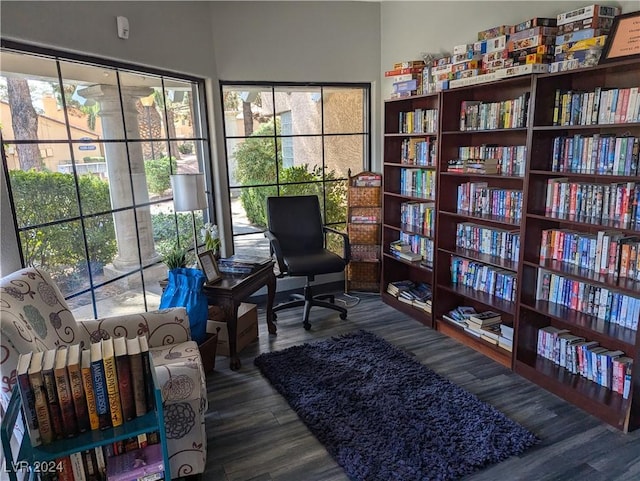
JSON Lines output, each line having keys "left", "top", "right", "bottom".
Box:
{"left": 160, "top": 267, "right": 208, "bottom": 344}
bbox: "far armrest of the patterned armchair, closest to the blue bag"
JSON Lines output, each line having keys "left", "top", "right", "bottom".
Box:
{"left": 78, "top": 307, "right": 191, "bottom": 347}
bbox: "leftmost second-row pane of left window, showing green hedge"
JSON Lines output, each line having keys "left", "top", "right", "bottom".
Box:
{"left": 4, "top": 144, "right": 80, "bottom": 228}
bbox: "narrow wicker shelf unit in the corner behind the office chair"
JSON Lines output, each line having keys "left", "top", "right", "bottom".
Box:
{"left": 345, "top": 171, "right": 382, "bottom": 292}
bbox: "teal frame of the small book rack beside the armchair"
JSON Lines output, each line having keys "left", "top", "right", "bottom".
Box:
{"left": 1, "top": 356, "right": 170, "bottom": 481}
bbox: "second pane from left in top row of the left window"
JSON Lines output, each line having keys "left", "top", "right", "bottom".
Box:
{"left": 59, "top": 58, "right": 124, "bottom": 142}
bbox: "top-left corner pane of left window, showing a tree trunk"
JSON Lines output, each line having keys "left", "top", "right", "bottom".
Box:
{"left": 0, "top": 52, "right": 65, "bottom": 146}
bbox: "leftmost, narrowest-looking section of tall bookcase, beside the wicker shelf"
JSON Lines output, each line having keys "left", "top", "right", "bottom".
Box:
{"left": 380, "top": 94, "right": 440, "bottom": 326}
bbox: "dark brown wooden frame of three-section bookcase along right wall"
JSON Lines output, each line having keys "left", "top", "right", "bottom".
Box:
{"left": 381, "top": 60, "right": 640, "bottom": 431}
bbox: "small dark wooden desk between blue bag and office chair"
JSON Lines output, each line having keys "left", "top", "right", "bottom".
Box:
{"left": 202, "top": 262, "right": 277, "bottom": 371}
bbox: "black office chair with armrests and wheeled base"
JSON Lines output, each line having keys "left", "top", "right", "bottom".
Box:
{"left": 265, "top": 195, "right": 350, "bottom": 330}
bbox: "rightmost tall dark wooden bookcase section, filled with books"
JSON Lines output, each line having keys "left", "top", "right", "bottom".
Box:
{"left": 514, "top": 57, "right": 640, "bottom": 431}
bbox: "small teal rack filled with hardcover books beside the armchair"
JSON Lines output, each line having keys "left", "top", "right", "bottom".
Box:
{"left": 1, "top": 336, "right": 169, "bottom": 481}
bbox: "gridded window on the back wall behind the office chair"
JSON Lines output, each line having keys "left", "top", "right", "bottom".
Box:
{"left": 221, "top": 82, "right": 370, "bottom": 254}
